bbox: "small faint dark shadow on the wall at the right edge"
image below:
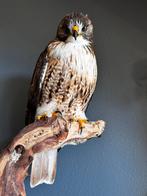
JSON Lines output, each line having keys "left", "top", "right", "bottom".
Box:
{"left": 132, "top": 59, "right": 147, "bottom": 101}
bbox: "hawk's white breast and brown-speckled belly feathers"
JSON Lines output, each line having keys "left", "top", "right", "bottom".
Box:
{"left": 37, "top": 41, "right": 97, "bottom": 117}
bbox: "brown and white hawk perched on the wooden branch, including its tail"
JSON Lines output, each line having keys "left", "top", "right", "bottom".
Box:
{"left": 26, "top": 13, "right": 97, "bottom": 187}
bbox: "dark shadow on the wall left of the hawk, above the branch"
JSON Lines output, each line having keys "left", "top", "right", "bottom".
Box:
{"left": 0, "top": 76, "right": 30, "bottom": 148}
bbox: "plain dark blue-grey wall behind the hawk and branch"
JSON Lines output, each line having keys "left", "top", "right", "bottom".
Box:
{"left": 0, "top": 0, "right": 147, "bottom": 196}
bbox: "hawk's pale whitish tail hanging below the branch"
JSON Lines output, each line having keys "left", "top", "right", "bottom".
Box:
{"left": 30, "top": 149, "right": 57, "bottom": 187}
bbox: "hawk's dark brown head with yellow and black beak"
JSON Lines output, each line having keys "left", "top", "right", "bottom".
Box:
{"left": 57, "top": 13, "right": 93, "bottom": 41}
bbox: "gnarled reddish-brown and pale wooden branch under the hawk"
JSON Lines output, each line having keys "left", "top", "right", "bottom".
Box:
{"left": 0, "top": 116, "right": 105, "bottom": 196}
